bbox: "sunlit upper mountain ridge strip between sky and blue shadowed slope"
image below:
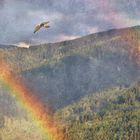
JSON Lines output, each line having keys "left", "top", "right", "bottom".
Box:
{"left": 0, "top": 26, "right": 140, "bottom": 72}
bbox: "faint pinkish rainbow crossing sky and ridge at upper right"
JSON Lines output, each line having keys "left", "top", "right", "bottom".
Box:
{"left": 96, "top": 0, "right": 140, "bottom": 65}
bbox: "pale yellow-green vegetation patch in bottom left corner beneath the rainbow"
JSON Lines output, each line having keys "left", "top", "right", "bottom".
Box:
{"left": 0, "top": 117, "right": 45, "bottom": 140}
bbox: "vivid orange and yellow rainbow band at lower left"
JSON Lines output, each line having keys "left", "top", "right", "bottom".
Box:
{"left": 0, "top": 61, "right": 63, "bottom": 140}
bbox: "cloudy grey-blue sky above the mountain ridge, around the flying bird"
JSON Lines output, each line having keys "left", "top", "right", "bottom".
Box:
{"left": 0, "top": 0, "right": 140, "bottom": 44}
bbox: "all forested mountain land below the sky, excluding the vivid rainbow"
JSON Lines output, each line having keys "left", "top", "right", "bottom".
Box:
{"left": 0, "top": 26, "right": 140, "bottom": 140}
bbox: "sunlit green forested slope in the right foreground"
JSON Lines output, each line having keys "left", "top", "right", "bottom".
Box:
{"left": 56, "top": 83, "right": 140, "bottom": 140}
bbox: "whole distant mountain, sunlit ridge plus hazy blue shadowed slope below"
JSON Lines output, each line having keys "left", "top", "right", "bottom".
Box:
{"left": 0, "top": 26, "right": 140, "bottom": 113}
